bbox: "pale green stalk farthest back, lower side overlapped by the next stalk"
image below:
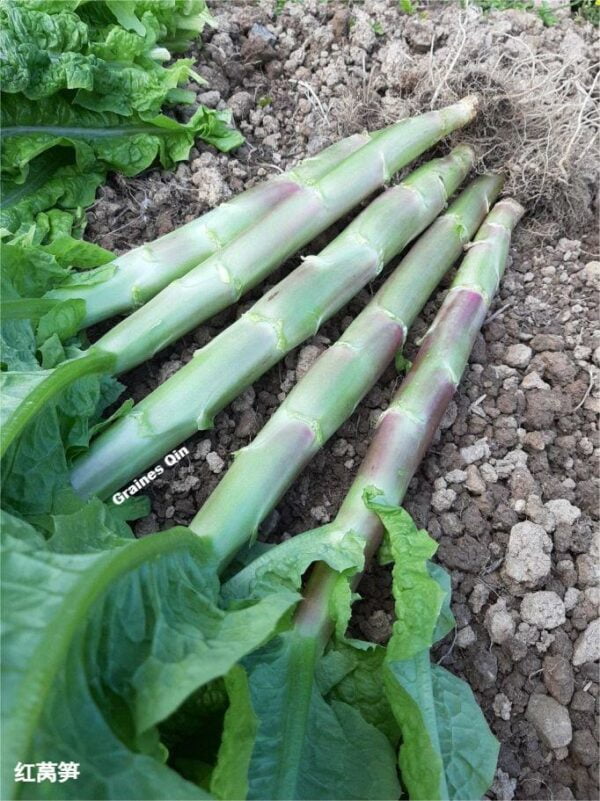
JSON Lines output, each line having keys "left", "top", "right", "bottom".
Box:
{"left": 48, "top": 134, "right": 373, "bottom": 327}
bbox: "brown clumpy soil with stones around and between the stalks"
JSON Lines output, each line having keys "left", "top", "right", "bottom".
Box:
{"left": 87, "top": 0, "right": 600, "bottom": 799}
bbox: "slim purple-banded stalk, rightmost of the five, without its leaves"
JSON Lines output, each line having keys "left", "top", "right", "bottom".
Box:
{"left": 296, "top": 199, "right": 523, "bottom": 639}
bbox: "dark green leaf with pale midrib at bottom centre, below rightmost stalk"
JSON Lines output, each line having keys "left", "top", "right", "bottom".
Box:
{"left": 237, "top": 631, "right": 400, "bottom": 799}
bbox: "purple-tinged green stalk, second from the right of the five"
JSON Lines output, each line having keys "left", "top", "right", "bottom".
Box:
{"left": 190, "top": 178, "right": 500, "bottom": 563}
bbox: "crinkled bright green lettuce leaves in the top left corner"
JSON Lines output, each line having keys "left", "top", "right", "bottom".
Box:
{"left": 0, "top": 0, "right": 243, "bottom": 250}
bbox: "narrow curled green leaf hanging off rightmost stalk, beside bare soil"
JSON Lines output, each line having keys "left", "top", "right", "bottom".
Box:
{"left": 365, "top": 500, "right": 499, "bottom": 801}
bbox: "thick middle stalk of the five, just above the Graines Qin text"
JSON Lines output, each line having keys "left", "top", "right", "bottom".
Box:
{"left": 72, "top": 152, "right": 498, "bottom": 496}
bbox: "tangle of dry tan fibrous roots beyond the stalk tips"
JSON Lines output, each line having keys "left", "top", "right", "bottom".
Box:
{"left": 331, "top": 9, "right": 600, "bottom": 237}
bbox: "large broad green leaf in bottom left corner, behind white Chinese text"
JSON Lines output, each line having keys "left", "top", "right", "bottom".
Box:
{"left": 2, "top": 520, "right": 296, "bottom": 799}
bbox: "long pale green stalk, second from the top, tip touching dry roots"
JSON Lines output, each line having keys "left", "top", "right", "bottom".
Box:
{"left": 1, "top": 97, "right": 477, "bottom": 454}
